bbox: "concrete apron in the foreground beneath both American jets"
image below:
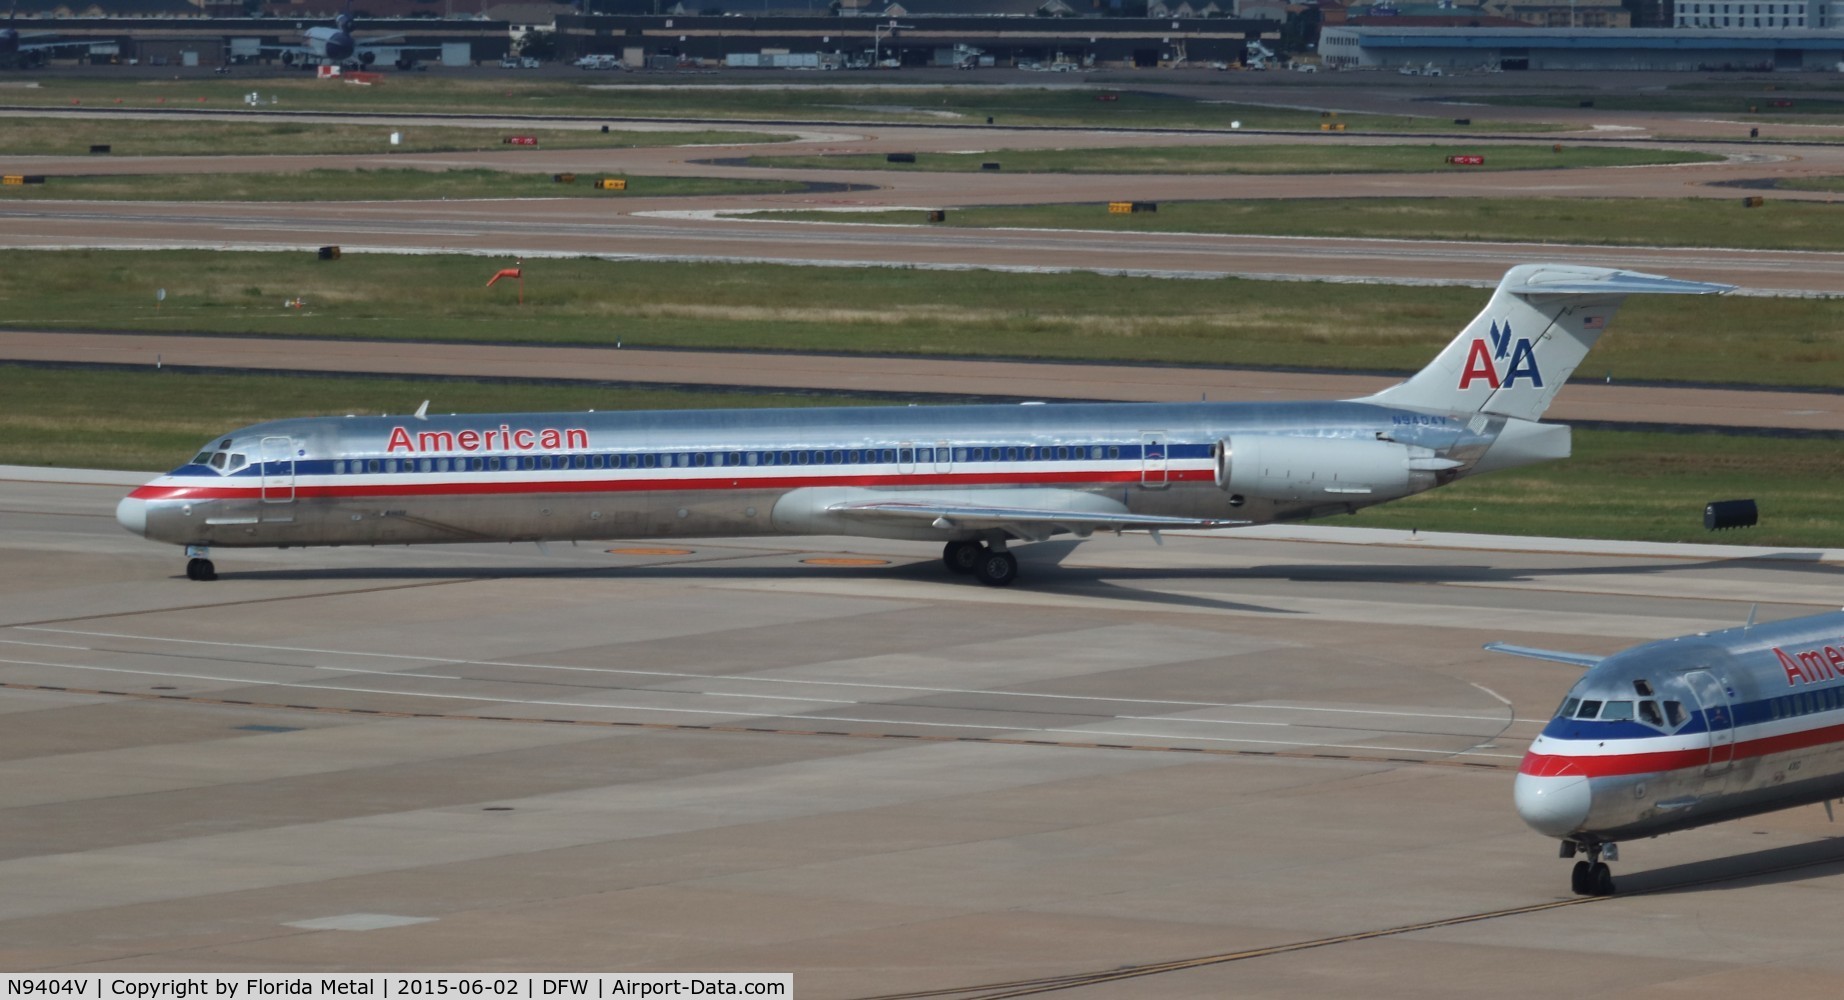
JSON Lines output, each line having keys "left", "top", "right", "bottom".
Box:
{"left": 0, "top": 470, "right": 1844, "bottom": 998}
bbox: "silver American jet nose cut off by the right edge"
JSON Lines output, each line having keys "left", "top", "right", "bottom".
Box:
{"left": 1486, "top": 611, "right": 1844, "bottom": 895}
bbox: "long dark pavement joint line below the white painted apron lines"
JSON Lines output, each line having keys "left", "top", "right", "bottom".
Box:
{"left": 0, "top": 682, "right": 1514, "bottom": 774}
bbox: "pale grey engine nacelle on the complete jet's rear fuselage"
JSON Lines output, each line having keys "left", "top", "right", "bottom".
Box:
{"left": 1217, "top": 434, "right": 1416, "bottom": 502}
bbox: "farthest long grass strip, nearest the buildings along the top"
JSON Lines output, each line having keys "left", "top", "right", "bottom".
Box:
{"left": 6, "top": 74, "right": 1551, "bottom": 131}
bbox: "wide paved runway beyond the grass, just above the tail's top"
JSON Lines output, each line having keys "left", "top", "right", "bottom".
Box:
{"left": 0, "top": 199, "right": 1844, "bottom": 295}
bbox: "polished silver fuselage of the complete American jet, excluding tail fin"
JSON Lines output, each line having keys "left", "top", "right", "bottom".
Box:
{"left": 124, "top": 402, "right": 1541, "bottom": 546}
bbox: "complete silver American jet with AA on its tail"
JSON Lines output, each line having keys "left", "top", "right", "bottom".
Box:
{"left": 116, "top": 264, "right": 1730, "bottom": 587}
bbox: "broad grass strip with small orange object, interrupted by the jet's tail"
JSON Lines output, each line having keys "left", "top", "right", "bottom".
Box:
{"left": 0, "top": 251, "right": 1844, "bottom": 389}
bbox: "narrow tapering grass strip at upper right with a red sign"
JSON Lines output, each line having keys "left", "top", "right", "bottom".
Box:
{"left": 749, "top": 142, "right": 1722, "bottom": 173}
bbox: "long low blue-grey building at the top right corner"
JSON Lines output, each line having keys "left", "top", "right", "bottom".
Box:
{"left": 1318, "top": 26, "right": 1844, "bottom": 74}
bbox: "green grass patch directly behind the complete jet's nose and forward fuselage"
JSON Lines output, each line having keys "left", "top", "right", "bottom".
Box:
{"left": 0, "top": 363, "right": 863, "bottom": 470}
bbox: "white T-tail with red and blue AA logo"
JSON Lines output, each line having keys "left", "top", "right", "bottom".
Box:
{"left": 1359, "top": 264, "right": 1735, "bottom": 421}
